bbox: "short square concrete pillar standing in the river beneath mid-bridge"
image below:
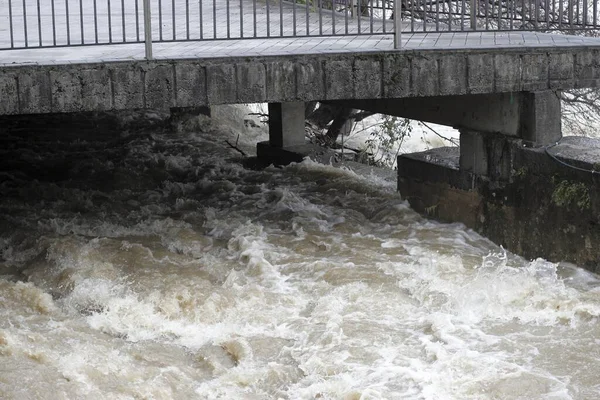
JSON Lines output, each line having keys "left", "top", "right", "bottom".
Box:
{"left": 269, "top": 101, "right": 305, "bottom": 148}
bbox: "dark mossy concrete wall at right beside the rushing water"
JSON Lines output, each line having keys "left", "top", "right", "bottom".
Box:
{"left": 398, "top": 138, "right": 600, "bottom": 272}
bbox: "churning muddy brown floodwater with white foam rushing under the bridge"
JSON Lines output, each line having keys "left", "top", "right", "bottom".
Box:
{"left": 0, "top": 108, "right": 600, "bottom": 400}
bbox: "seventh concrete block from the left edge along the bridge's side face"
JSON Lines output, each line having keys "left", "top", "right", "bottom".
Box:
{"left": 175, "top": 63, "right": 208, "bottom": 107}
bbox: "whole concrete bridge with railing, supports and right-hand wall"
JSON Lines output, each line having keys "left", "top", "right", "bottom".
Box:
{"left": 0, "top": 0, "right": 600, "bottom": 265}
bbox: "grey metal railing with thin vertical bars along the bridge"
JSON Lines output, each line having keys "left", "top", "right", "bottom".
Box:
{"left": 0, "top": 0, "right": 600, "bottom": 54}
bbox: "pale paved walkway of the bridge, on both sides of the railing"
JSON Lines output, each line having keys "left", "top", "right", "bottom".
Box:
{"left": 0, "top": 0, "right": 600, "bottom": 65}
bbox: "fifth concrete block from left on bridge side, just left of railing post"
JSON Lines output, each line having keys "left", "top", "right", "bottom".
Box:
{"left": 110, "top": 64, "right": 144, "bottom": 110}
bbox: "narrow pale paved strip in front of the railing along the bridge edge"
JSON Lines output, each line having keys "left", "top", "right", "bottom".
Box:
{"left": 0, "top": 32, "right": 600, "bottom": 66}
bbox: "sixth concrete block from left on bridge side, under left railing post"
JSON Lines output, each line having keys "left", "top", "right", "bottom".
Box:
{"left": 144, "top": 64, "right": 175, "bottom": 109}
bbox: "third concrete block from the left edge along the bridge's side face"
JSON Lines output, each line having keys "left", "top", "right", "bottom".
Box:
{"left": 50, "top": 68, "right": 82, "bottom": 113}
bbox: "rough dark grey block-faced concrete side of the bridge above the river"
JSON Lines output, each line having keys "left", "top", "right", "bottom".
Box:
{"left": 0, "top": 46, "right": 600, "bottom": 115}
